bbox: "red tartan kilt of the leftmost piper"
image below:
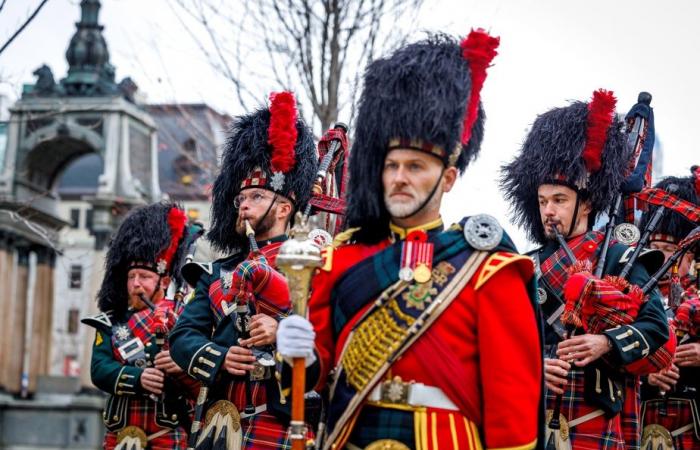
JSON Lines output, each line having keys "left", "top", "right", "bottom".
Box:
{"left": 103, "top": 396, "right": 187, "bottom": 450}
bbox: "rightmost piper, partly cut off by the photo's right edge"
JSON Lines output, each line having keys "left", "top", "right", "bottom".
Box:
{"left": 641, "top": 166, "right": 700, "bottom": 450}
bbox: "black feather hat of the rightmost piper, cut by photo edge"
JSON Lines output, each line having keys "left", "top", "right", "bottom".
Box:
{"left": 639, "top": 166, "right": 700, "bottom": 242}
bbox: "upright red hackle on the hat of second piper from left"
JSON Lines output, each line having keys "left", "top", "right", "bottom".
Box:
{"left": 267, "top": 91, "right": 298, "bottom": 173}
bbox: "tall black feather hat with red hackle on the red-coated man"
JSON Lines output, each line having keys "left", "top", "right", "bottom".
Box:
{"left": 345, "top": 30, "right": 499, "bottom": 243}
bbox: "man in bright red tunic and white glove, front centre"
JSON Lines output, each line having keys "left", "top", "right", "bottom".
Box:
{"left": 277, "top": 30, "right": 542, "bottom": 450}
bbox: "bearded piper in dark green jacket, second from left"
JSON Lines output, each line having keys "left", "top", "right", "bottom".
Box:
{"left": 170, "top": 92, "right": 317, "bottom": 450}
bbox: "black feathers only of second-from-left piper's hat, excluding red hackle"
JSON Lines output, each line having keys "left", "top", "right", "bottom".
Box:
{"left": 207, "top": 108, "right": 318, "bottom": 253}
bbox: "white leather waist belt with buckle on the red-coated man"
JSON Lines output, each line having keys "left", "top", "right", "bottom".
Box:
{"left": 367, "top": 380, "right": 459, "bottom": 411}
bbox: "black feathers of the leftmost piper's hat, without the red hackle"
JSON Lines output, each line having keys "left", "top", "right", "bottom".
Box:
{"left": 97, "top": 203, "right": 187, "bottom": 318}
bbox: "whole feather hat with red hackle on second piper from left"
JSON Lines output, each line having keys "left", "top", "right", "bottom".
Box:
{"left": 207, "top": 92, "right": 318, "bottom": 252}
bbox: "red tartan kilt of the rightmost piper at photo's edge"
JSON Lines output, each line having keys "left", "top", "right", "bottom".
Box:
{"left": 642, "top": 397, "right": 700, "bottom": 450}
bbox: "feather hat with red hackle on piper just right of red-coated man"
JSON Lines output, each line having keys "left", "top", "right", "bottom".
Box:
{"left": 501, "top": 90, "right": 631, "bottom": 244}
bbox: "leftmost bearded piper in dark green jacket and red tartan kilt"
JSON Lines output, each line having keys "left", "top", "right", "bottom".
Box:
{"left": 83, "top": 204, "right": 195, "bottom": 450}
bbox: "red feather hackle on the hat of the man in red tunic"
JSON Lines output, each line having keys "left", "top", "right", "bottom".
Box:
{"left": 460, "top": 28, "right": 500, "bottom": 145}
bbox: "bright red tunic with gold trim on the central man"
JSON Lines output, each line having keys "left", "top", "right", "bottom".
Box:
{"left": 309, "top": 222, "right": 542, "bottom": 449}
